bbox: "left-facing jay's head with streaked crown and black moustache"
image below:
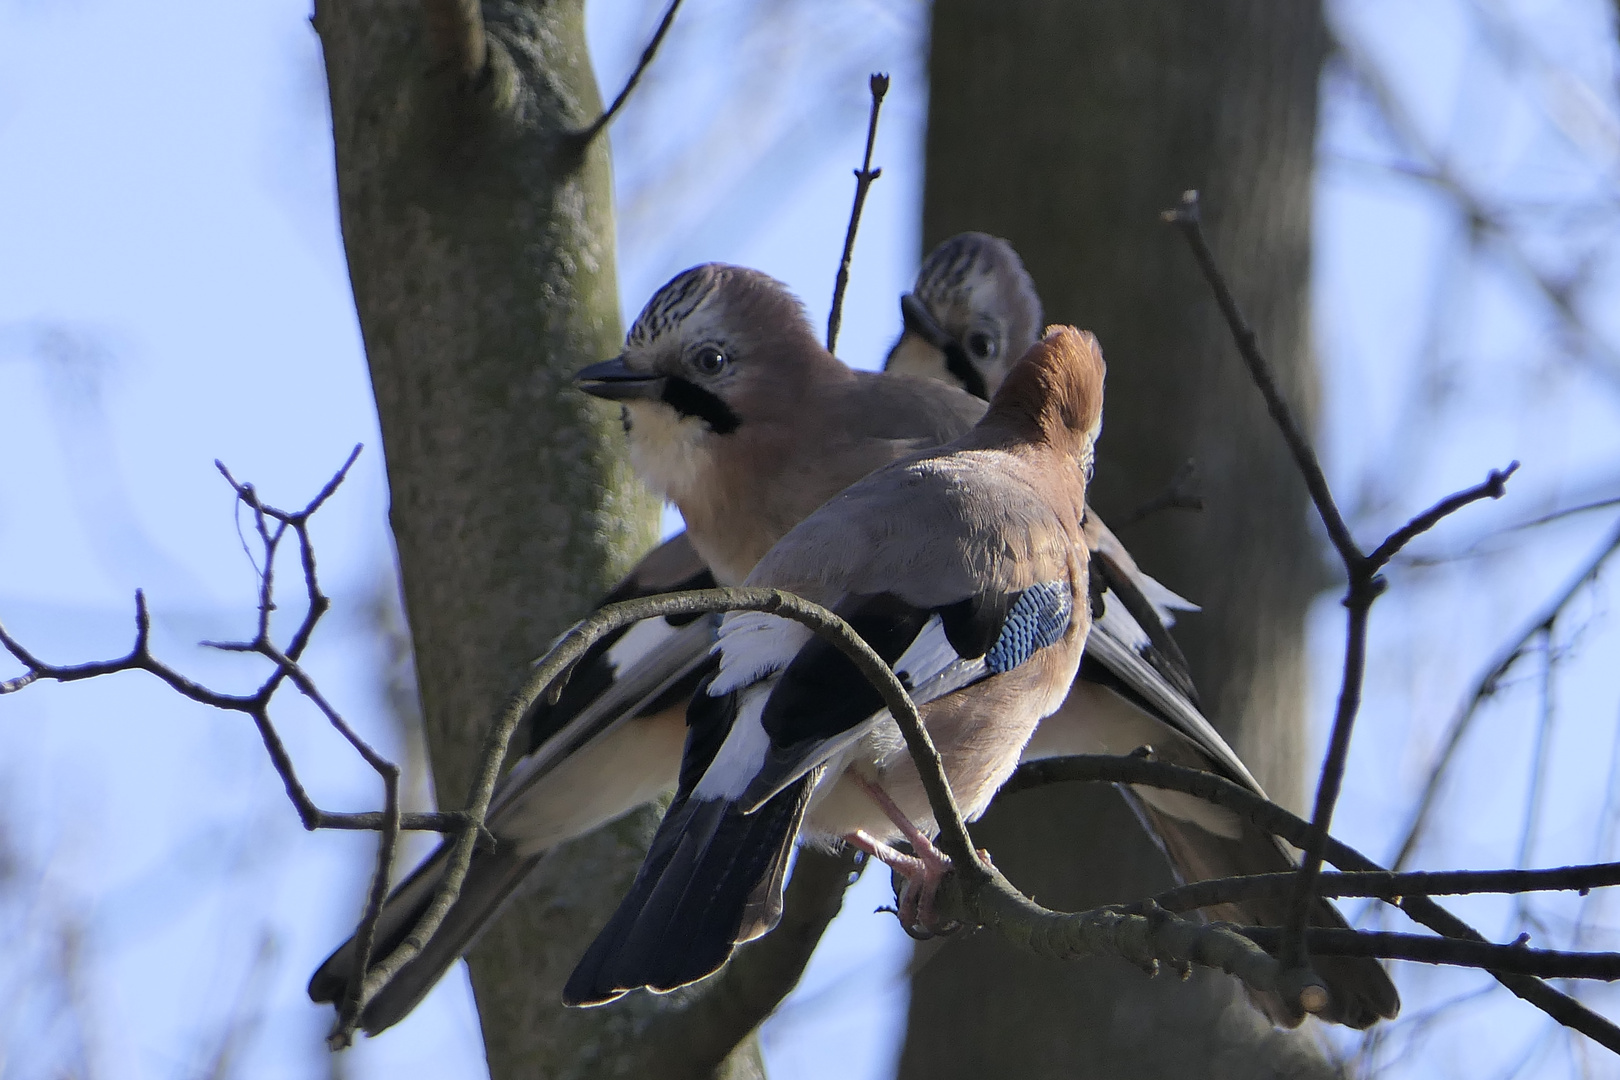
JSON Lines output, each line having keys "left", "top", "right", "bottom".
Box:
{"left": 575, "top": 270, "right": 847, "bottom": 502}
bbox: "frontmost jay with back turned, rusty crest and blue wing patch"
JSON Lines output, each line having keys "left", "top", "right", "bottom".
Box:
{"left": 564, "top": 327, "right": 1103, "bottom": 1006}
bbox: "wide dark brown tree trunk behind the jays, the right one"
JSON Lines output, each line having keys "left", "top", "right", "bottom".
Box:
{"left": 901, "top": 0, "right": 1327, "bottom": 1080}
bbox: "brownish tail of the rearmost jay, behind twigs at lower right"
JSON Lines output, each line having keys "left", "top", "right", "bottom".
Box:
{"left": 1121, "top": 789, "right": 1401, "bottom": 1028}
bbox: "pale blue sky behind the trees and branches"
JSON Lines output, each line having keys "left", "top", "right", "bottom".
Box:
{"left": 0, "top": 0, "right": 1620, "bottom": 1077}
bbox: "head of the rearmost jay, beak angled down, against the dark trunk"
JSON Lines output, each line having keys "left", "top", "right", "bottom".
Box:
{"left": 885, "top": 233, "right": 1042, "bottom": 398}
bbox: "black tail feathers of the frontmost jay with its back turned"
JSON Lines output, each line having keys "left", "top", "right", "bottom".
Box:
{"left": 562, "top": 776, "right": 815, "bottom": 1006}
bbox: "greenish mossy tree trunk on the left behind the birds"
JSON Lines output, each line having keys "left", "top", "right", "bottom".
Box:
{"left": 316, "top": 0, "right": 673, "bottom": 1080}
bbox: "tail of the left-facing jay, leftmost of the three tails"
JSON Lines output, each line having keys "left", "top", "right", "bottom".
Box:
{"left": 309, "top": 844, "right": 544, "bottom": 1035}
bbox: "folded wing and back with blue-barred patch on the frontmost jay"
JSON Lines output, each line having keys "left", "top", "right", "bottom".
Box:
{"left": 689, "top": 453, "right": 1079, "bottom": 810}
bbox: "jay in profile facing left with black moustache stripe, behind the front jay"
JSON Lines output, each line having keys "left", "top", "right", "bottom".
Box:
{"left": 309, "top": 264, "right": 985, "bottom": 1033}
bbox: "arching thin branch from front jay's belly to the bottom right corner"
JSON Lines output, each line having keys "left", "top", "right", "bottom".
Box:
{"left": 1001, "top": 755, "right": 1620, "bottom": 1054}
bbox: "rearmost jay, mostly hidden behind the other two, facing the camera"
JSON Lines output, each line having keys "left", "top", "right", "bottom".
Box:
{"left": 886, "top": 233, "right": 1400, "bottom": 1028}
